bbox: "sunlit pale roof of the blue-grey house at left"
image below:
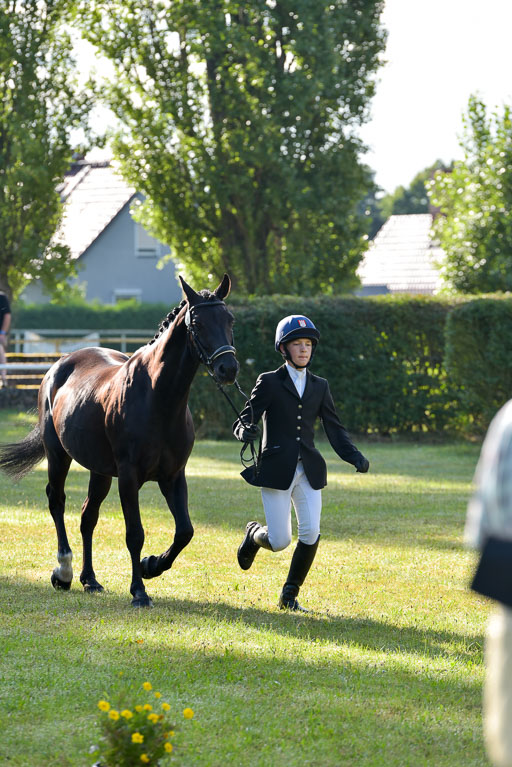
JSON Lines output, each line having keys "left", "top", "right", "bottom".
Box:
{"left": 56, "top": 161, "right": 136, "bottom": 258}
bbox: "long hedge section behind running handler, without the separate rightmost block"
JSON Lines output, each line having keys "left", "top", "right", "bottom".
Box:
{"left": 186, "top": 296, "right": 459, "bottom": 435}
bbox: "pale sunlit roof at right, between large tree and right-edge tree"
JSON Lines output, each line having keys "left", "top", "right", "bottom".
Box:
{"left": 357, "top": 213, "right": 444, "bottom": 295}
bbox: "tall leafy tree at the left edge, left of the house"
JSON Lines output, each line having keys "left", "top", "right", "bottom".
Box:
{"left": 0, "top": 0, "right": 90, "bottom": 297}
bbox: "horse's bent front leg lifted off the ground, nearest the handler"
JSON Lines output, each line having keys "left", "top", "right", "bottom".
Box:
{"left": 140, "top": 470, "right": 194, "bottom": 578}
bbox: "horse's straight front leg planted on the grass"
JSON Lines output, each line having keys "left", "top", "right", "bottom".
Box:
{"left": 118, "top": 466, "right": 153, "bottom": 607}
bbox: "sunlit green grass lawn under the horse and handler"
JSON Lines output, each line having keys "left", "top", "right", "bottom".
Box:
{"left": 0, "top": 411, "right": 492, "bottom": 767}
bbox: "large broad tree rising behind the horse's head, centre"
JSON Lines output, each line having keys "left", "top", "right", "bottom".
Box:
{"left": 78, "top": 0, "right": 385, "bottom": 294}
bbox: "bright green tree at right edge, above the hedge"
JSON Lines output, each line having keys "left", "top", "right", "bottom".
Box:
{"left": 429, "top": 96, "right": 512, "bottom": 293}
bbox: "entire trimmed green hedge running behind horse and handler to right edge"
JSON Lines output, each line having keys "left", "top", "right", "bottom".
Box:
{"left": 13, "top": 296, "right": 512, "bottom": 436}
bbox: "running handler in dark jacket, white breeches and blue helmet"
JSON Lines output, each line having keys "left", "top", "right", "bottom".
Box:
{"left": 233, "top": 315, "right": 369, "bottom": 612}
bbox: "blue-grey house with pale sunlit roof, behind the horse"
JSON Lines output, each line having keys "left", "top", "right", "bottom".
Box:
{"left": 22, "top": 160, "right": 181, "bottom": 305}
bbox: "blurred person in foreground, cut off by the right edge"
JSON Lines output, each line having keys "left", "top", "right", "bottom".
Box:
{"left": 465, "top": 400, "right": 512, "bottom": 767}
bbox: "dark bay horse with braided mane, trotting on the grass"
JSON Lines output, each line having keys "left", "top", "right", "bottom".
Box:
{"left": 0, "top": 275, "right": 238, "bottom": 607}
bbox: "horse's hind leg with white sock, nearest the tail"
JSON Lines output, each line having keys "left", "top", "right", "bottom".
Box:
{"left": 46, "top": 443, "right": 73, "bottom": 591}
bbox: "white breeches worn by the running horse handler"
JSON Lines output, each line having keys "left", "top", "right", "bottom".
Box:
{"left": 261, "top": 461, "right": 322, "bottom": 551}
